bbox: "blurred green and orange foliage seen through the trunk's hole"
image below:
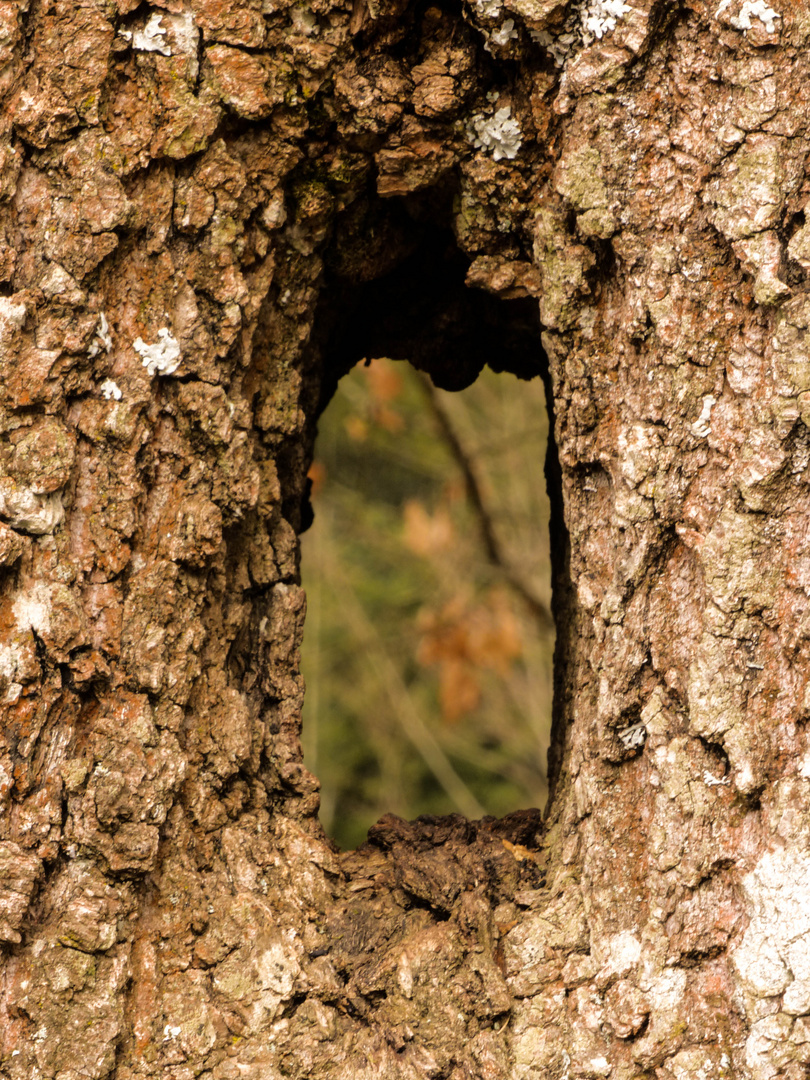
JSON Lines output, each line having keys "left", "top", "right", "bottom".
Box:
{"left": 301, "top": 360, "right": 553, "bottom": 848}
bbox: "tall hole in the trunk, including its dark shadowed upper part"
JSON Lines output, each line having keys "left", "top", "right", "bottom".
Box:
{"left": 301, "top": 181, "right": 553, "bottom": 848}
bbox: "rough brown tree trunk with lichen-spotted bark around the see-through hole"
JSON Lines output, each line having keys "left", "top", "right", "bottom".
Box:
{"left": 0, "top": 0, "right": 810, "bottom": 1080}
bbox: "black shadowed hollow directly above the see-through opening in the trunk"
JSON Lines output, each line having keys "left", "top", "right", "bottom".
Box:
{"left": 308, "top": 178, "right": 548, "bottom": 397}
